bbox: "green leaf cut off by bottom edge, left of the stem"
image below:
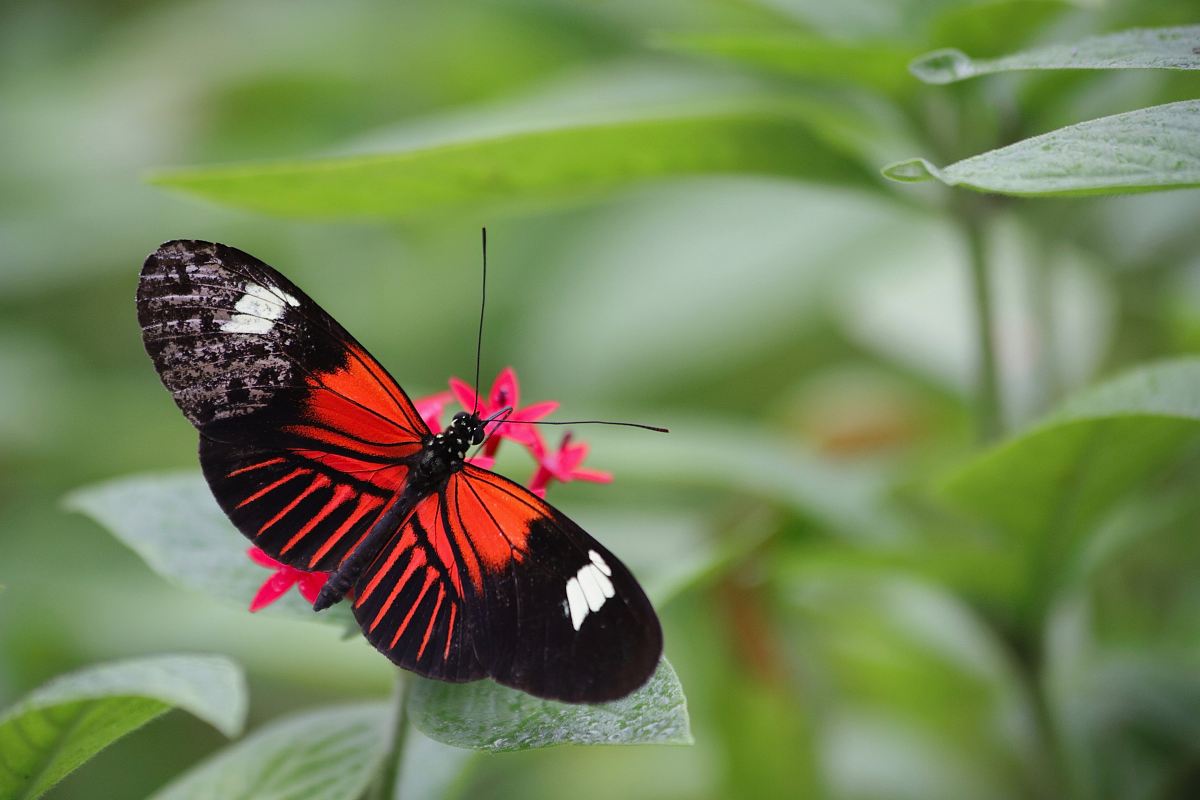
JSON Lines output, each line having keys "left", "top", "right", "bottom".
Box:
{"left": 144, "top": 703, "right": 391, "bottom": 800}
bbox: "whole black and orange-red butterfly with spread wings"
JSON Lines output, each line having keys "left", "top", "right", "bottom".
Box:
{"left": 137, "top": 240, "right": 662, "bottom": 703}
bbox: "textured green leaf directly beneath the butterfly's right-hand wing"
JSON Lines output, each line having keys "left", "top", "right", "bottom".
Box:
{"left": 408, "top": 658, "right": 692, "bottom": 751}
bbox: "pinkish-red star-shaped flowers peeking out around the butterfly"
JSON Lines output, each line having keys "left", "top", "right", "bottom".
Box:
{"left": 248, "top": 367, "right": 612, "bottom": 612}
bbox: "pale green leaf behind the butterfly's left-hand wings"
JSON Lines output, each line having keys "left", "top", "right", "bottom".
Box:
{"left": 65, "top": 471, "right": 349, "bottom": 626}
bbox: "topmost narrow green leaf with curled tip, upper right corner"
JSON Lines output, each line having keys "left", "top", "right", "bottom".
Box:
{"left": 908, "top": 25, "right": 1200, "bottom": 84}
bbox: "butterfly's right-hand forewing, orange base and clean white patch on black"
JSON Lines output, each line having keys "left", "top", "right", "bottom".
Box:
{"left": 446, "top": 464, "right": 662, "bottom": 703}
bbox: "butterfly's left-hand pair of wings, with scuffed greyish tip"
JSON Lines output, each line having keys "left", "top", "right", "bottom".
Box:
{"left": 138, "top": 241, "right": 428, "bottom": 570}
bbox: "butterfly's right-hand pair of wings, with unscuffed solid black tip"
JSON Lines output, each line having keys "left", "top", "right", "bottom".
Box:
{"left": 354, "top": 464, "right": 662, "bottom": 703}
